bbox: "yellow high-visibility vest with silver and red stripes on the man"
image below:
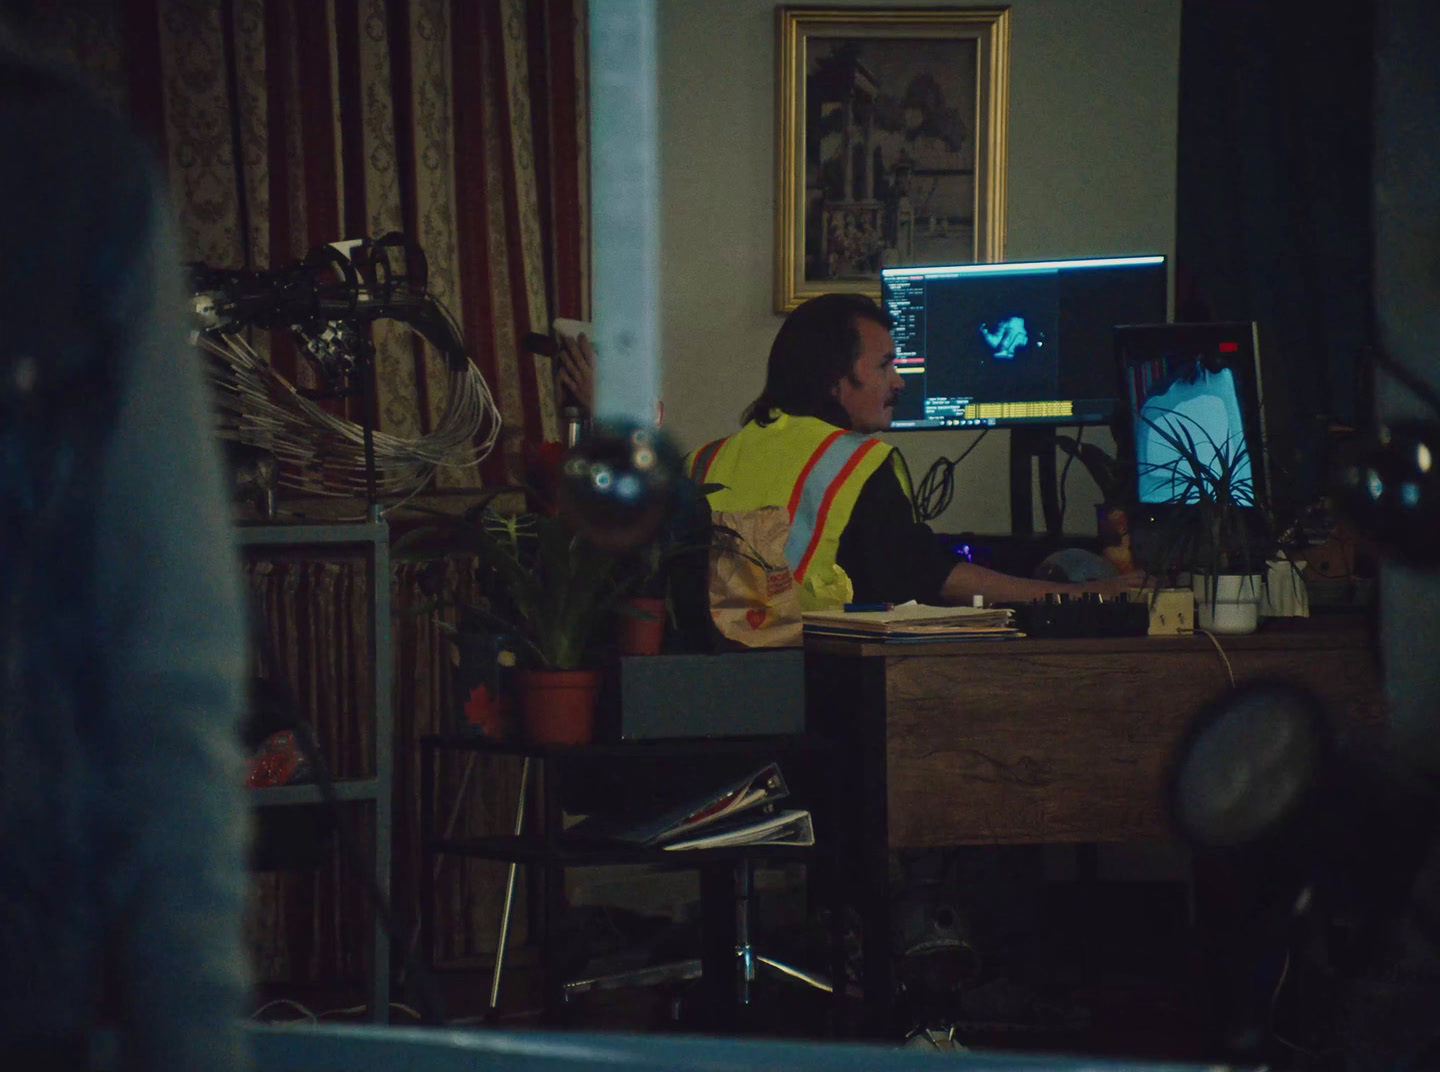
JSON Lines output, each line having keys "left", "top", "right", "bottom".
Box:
{"left": 687, "top": 414, "right": 907, "bottom": 611}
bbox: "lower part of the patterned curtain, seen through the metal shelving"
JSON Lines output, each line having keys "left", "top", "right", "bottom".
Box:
{"left": 246, "top": 550, "right": 527, "bottom": 991}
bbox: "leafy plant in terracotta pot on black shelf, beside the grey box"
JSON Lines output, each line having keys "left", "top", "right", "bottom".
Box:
{"left": 396, "top": 500, "right": 624, "bottom": 745}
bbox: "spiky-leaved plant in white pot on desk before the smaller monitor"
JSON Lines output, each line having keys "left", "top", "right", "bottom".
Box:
{"left": 1138, "top": 409, "right": 1279, "bottom": 634}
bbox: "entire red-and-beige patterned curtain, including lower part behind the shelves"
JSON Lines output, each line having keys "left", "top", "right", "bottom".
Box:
{"left": 32, "top": 0, "right": 589, "bottom": 993}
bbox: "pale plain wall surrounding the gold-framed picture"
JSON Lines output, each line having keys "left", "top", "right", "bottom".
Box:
{"left": 660, "top": 0, "right": 1179, "bottom": 533}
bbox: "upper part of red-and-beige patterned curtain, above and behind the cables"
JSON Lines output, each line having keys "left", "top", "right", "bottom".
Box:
{"left": 39, "top": 0, "right": 589, "bottom": 487}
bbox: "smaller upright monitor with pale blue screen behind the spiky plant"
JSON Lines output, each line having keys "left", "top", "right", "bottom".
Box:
{"left": 1115, "top": 321, "right": 1269, "bottom": 517}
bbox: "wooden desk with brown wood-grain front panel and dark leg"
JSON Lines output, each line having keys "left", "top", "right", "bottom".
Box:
{"left": 806, "top": 620, "right": 1382, "bottom": 1033}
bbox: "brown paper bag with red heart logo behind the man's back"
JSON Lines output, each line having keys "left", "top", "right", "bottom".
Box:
{"left": 710, "top": 506, "right": 804, "bottom": 647}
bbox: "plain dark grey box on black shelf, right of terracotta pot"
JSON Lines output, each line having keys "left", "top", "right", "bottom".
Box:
{"left": 602, "top": 648, "right": 805, "bottom": 741}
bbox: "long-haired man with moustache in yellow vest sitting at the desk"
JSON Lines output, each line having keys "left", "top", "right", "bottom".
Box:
{"left": 688, "top": 294, "right": 1142, "bottom": 609}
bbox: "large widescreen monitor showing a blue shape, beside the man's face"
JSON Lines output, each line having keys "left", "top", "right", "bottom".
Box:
{"left": 881, "top": 255, "right": 1168, "bottom": 429}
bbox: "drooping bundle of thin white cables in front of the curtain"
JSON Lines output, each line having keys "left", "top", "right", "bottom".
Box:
{"left": 197, "top": 319, "right": 501, "bottom": 497}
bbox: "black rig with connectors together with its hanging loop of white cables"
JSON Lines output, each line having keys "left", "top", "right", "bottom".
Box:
{"left": 190, "top": 232, "right": 501, "bottom": 504}
